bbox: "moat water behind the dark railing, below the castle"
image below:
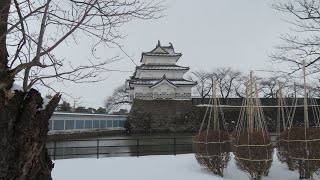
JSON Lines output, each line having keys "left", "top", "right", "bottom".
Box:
{"left": 47, "top": 133, "right": 276, "bottom": 159}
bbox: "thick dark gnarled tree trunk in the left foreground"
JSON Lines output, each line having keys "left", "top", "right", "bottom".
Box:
{"left": 0, "top": 89, "right": 60, "bottom": 180}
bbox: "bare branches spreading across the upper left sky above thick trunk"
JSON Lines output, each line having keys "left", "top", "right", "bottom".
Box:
{"left": 0, "top": 0, "right": 165, "bottom": 91}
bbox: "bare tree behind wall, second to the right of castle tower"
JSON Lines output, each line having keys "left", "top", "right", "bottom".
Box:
{"left": 212, "top": 67, "right": 241, "bottom": 98}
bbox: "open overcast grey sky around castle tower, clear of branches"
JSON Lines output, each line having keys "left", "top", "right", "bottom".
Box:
{"left": 48, "top": 0, "right": 288, "bottom": 107}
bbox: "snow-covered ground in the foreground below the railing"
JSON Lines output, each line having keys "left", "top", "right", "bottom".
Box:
{"left": 53, "top": 154, "right": 319, "bottom": 180}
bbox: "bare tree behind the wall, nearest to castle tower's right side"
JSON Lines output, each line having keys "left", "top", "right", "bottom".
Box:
{"left": 188, "top": 71, "right": 212, "bottom": 104}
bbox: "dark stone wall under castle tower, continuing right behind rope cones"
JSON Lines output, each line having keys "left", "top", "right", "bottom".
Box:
{"left": 126, "top": 98, "right": 320, "bottom": 132}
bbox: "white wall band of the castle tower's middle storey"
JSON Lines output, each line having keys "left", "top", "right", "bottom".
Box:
{"left": 137, "top": 70, "right": 186, "bottom": 79}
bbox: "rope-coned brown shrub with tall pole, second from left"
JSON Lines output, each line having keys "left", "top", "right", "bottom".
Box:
{"left": 233, "top": 72, "right": 273, "bottom": 180}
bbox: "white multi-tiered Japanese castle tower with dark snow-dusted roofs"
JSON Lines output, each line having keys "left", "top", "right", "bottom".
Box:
{"left": 126, "top": 41, "right": 197, "bottom": 100}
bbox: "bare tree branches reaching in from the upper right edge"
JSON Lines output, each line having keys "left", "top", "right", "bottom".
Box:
{"left": 270, "top": 0, "right": 320, "bottom": 74}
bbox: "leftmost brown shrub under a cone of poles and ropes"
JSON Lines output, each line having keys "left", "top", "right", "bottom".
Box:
{"left": 193, "top": 81, "right": 230, "bottom": 177}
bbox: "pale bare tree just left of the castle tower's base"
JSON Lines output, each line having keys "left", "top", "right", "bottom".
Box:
{"left": 104, "top": 85, "right": 132, "bottom": 113}
